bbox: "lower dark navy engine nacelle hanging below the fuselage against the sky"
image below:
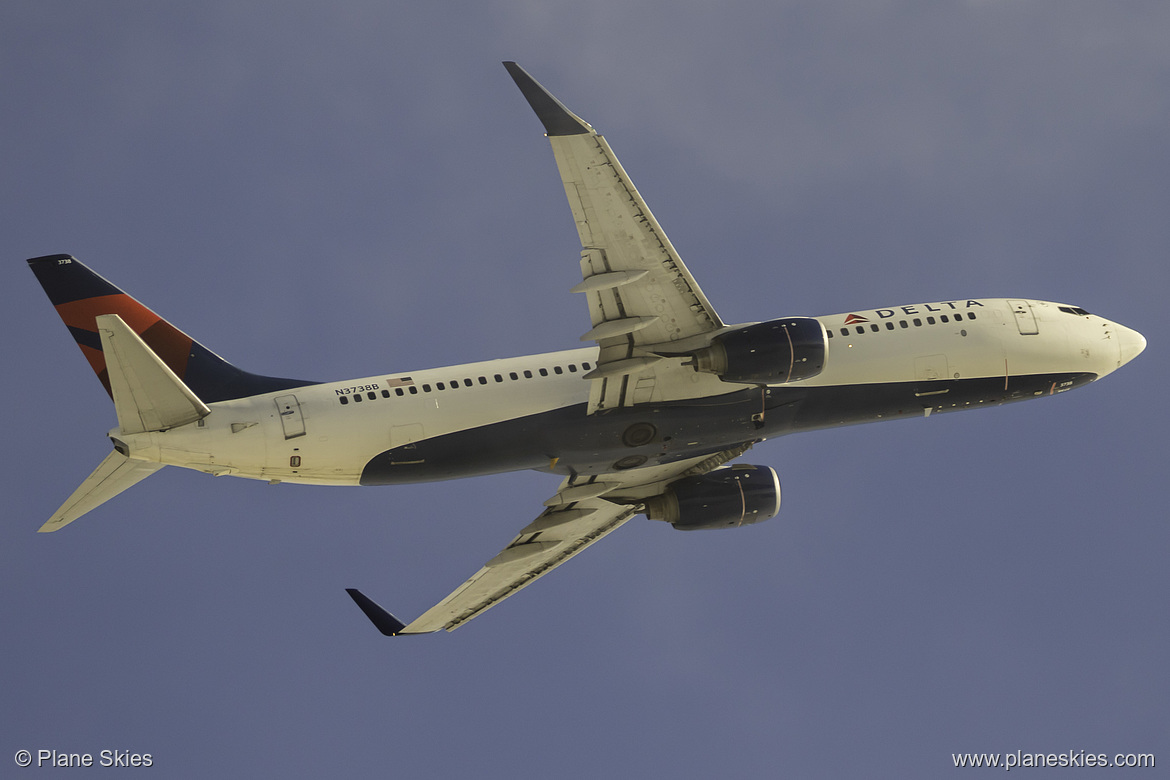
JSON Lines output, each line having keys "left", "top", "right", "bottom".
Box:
{"left": 646, "top": 464, "right": 780, "bottom": 531}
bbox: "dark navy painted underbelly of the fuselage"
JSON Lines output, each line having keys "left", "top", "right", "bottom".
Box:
{"left": 362, "top": 373, "right": 1095, "bottom": 485}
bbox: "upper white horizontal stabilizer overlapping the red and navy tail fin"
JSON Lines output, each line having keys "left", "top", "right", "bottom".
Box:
{"left": 96, "top": 315, "right": 211, "bottom": 434}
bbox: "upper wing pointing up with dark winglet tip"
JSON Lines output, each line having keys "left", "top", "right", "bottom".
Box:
{"left": 504, "top": 62, "right": 723, "bottom": 414}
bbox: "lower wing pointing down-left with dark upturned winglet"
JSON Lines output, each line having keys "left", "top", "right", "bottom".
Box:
{"left": 346, "top": 443, "right": 751, "bottom": 636}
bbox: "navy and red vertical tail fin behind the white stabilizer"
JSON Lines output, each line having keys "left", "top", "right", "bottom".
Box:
{"left": 28, "top": 255, "right": 312, "bottom": 403}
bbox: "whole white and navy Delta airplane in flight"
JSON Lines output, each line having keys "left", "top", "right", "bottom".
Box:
{"left": 28, "top": 62, "right": 1145, "bottom": 636}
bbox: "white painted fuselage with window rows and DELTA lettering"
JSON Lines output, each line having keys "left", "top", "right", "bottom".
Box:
{"left": 118, "top": 298, "right": 1144, "bottom": 485}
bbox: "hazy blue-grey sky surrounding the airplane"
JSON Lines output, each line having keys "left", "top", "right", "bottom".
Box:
{"left": 0, "top": 0, "right": 1170, "bottom": 778}
